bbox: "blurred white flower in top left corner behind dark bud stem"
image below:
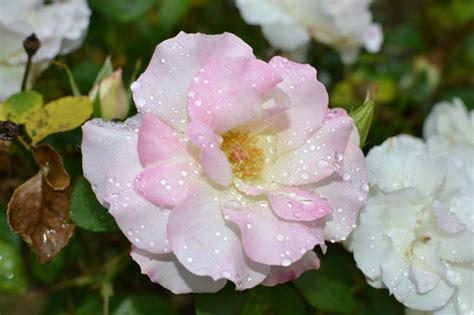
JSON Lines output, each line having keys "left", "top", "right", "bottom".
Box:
{"left": 0, "top": 0, "right": 90, "bottom": 100}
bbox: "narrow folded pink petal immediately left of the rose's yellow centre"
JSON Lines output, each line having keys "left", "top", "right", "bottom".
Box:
{"left": 188, "top": 121, "right": 232, "bottom": 187}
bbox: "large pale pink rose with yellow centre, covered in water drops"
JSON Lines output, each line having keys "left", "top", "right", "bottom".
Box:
{"left": 83, "top": 33, "right": 367, "bottom": 293}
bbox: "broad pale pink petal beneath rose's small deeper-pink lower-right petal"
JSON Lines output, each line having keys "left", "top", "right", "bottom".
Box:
{"left": 222, "top": 199, "right": 324, "bottom": 267}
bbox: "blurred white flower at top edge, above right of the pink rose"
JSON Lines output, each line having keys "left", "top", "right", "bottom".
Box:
{"left": 236, "top": 0, "right": 383, "bottom": 63}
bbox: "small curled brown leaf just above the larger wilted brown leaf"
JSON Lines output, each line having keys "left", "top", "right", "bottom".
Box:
{"left": 31, "top": 144, "right": 70, "bottom": 190}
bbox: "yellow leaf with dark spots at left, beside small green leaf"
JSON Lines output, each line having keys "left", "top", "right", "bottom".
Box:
{"left": 26, "top": 96, "right": 93, "bottom": 144}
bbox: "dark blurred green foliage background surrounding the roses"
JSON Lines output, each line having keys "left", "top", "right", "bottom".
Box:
{"left": 0, "top": 0, "right": 474, "bottom": 315}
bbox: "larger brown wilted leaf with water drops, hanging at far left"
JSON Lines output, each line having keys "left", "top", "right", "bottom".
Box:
{"left": 7, "top": 171, "right": 74, "bottom": 263}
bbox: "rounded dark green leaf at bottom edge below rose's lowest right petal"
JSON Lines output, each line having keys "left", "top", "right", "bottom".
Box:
{"left": 242, "top": 283, "right": 308, "bottom": 315}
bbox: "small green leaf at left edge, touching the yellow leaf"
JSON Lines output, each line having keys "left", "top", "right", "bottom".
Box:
{"left": 3, "top": 91, "right": 43, "bottom": 124}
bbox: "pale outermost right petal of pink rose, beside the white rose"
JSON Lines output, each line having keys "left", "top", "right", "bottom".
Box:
{"left": 314, "top": 127, "right": 369, "bottom": 241}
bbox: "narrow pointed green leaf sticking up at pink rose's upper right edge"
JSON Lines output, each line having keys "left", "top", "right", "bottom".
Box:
{"left": 350, "top": 85, "right": 378, "bottom": 148}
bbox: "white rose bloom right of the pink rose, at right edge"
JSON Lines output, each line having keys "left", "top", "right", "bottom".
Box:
{"left": 352, "top": 100, "right": 474, "bottom": 315}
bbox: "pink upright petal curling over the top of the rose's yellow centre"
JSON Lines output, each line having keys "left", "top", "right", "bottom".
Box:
{"left": 188, "top": 58, "right": 281, "bottom": 133}
